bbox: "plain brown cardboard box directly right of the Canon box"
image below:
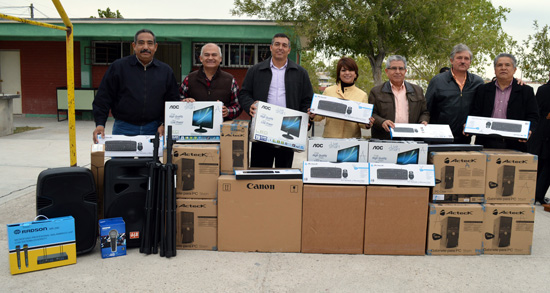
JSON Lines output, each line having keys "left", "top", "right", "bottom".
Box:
{"left": 302, "top": 184, "right": 367, "bottom": 254}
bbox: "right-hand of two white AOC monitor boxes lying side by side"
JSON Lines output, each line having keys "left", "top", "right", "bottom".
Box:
{"left": 368, "top": 140, "right": 428, "bottom": 165}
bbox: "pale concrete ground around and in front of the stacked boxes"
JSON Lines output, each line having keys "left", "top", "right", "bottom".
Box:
{"left": 0, "top": 117, "right": 550, "bottom": 292}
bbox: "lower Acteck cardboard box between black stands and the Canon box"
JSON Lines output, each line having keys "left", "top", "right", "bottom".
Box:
{"left": 176, "top": 199, "right": 218, "bottom": 250}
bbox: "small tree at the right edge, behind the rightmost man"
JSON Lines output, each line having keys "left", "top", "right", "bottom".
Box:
{"left": 518, "top": 21, "right": 550, "bottom": 82}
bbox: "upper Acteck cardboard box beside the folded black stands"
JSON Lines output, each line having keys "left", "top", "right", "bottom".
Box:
{"left": 172, "top": 144, "right": 220, "bottom": 198}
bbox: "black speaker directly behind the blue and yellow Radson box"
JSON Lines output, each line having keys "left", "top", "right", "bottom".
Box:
{"left": 36, "top": 167, "right": 98, "bottom": 254}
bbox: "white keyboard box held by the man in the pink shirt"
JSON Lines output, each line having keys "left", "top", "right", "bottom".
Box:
{"left": 464, "top": 116, "right": 531, "bottom": 139}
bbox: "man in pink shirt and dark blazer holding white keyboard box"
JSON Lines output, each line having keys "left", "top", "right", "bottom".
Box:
{"left": 470, "top": 53, "right": 539, "bottom": 152}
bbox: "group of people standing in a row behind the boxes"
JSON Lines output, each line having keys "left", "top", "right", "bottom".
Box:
{"left": 93, "top": 29, "right": 550, "bottom": 203}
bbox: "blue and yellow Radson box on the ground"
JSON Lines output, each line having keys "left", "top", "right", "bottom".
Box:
{"left": 7, "top": 216, "right": 76, "bottom": 274}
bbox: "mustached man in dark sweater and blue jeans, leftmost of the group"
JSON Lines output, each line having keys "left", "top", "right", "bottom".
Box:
{"left": 92, "top": 29, "right": 180, "bottom": 143}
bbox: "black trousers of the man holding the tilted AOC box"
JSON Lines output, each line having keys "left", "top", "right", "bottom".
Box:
{"left": 250, "top": 142, "right": 294, "bottom": 168}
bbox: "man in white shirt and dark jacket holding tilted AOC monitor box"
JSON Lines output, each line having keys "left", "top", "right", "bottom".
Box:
{"left": 239, "top": 34, "right": 313, "bottom": 168}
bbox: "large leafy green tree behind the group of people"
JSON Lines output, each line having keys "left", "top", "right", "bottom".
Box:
{"left": 232, "top": 0, "right": 509, "bottom": 84}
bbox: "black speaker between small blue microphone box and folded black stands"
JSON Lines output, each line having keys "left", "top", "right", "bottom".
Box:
{"left": 104, "top": 158, "right": 152, "bottom": 247}
